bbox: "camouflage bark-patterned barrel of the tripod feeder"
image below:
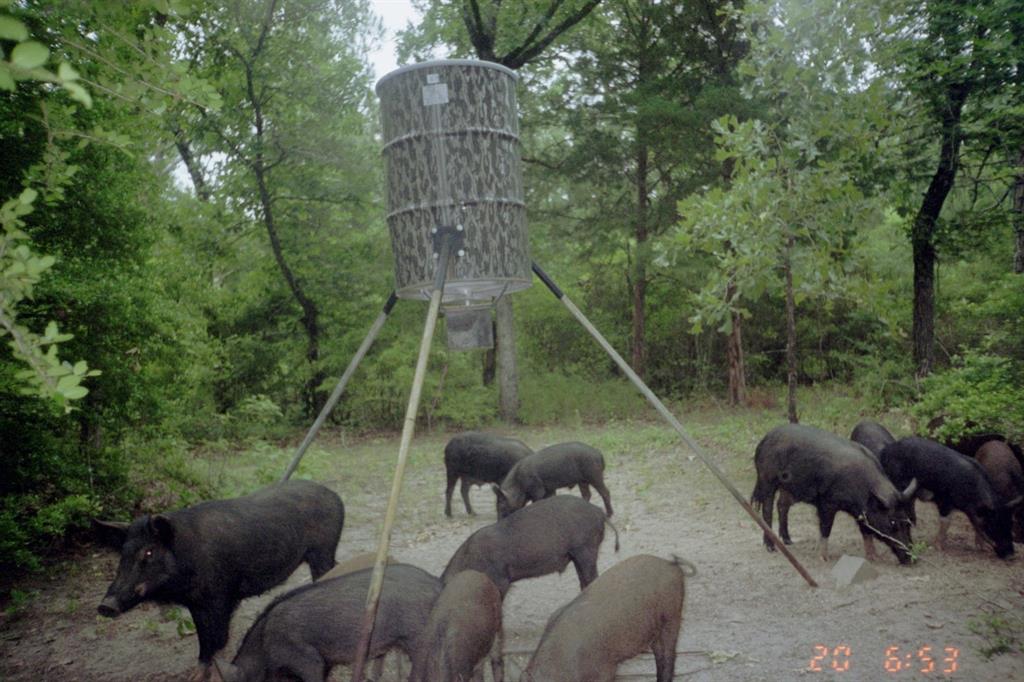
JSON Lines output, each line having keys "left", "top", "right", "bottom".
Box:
{"left": 377, "top": 59, "right": 531, "bottom": 303}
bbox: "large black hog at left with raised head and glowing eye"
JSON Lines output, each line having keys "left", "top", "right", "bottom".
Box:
{"left": 94, "top": 480, "right": 345, "bottom": 677}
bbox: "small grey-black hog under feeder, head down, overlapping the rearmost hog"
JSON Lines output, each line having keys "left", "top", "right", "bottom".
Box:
{"left": 494, "top": 441, "right": 611, "bottom": 518}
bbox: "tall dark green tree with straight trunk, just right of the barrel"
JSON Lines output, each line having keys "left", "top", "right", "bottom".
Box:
{"left": 531, "top": 0, "right": 744, "bottom": 376}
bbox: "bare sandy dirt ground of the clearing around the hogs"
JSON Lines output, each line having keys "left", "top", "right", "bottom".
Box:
{"left": 0, "top": 421, "right": 1024, "bottom": 682}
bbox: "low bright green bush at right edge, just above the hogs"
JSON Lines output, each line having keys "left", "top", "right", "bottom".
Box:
{"left": 911, "top": 350, "right": 1024, "bottom": 442}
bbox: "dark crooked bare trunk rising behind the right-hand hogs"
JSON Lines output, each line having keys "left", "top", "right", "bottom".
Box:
{"left": 910, "top": 84, "right": 969, "bottom": 377}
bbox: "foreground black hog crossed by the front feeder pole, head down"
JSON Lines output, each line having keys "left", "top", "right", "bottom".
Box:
{"left": 214, "top": 563, "right": 441, "bottom": 682}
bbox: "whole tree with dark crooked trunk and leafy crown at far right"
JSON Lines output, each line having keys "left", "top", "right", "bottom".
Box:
{"left": 880, "top": 0, "right": 1024, "bottom": 376}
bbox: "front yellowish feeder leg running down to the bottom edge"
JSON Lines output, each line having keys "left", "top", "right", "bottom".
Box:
{"left": 352, "top": 236, "right": 452, "bottom": 682}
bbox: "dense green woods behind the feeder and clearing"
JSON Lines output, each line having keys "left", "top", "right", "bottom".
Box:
{"left": 0, "top": 0, "right": 1024, "bottom": 570}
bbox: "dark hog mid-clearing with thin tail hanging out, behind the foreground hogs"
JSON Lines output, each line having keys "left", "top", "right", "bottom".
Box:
{"left": 441, "top": 495, "right": 618, "bottom": 598}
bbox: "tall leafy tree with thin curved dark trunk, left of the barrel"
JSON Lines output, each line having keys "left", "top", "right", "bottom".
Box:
{"left": 168, "top": 0, "right": 379, "bottom": 414}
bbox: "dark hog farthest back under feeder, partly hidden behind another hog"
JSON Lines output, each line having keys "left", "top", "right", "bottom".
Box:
{"left": 444, "top": 431, "right": 534, "bottom": 516}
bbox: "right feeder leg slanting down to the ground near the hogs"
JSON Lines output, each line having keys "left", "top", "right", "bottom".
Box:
{"left": 532, "top": 262, "right": 818, "bottom": 587}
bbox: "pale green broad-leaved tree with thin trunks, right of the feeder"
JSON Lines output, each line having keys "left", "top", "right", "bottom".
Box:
{"left": 680, "top": 2, "right": 885, "bottom": 409}
